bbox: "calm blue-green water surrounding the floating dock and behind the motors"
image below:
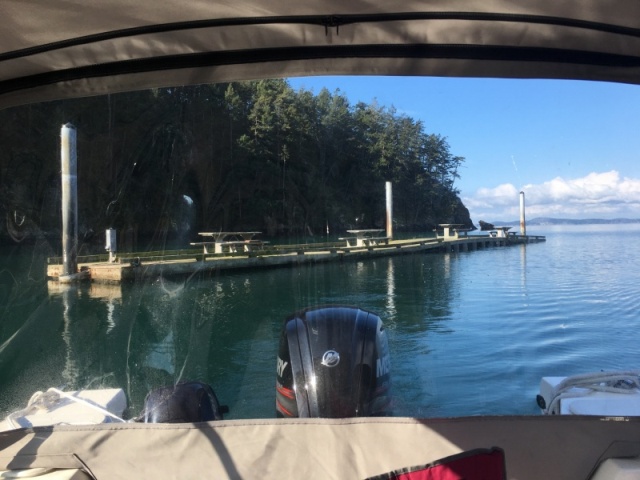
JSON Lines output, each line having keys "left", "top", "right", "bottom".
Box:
{"left": 0, "top": 225, "right": 640, "bottom": 418}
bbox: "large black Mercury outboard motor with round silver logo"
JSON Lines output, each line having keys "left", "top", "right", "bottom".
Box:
{"left": 276, "top": 306, "right": 391, "bottom": 418}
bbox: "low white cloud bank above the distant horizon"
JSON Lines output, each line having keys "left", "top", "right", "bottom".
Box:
{"left": 463, "top": 170, "right": 640, "bottom": 222}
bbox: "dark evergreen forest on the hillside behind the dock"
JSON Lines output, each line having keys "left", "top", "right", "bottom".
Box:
{"left": 0, "top": 80, "right": 471, "bottom": 248}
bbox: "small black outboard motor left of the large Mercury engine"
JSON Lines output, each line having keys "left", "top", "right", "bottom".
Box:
{"left": 141, "top": 382, "right": 229, "bottom": 423}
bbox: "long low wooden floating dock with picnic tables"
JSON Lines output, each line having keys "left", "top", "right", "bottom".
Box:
{"left": 47, "top": 235, "right": 546, "bottom": 283}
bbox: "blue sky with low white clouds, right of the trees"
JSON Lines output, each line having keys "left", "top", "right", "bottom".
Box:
{"left": 289, "top": 77, "right": 640, "bottom": 224}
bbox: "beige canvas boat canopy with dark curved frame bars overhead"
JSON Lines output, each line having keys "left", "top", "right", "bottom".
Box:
{"left": 0, "top": 0, "right": 640, "bottom": 108}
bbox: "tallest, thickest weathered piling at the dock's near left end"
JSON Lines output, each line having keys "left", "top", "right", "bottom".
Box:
{"left": 60, "top": 123, "right": 78, "bottom": 276}
